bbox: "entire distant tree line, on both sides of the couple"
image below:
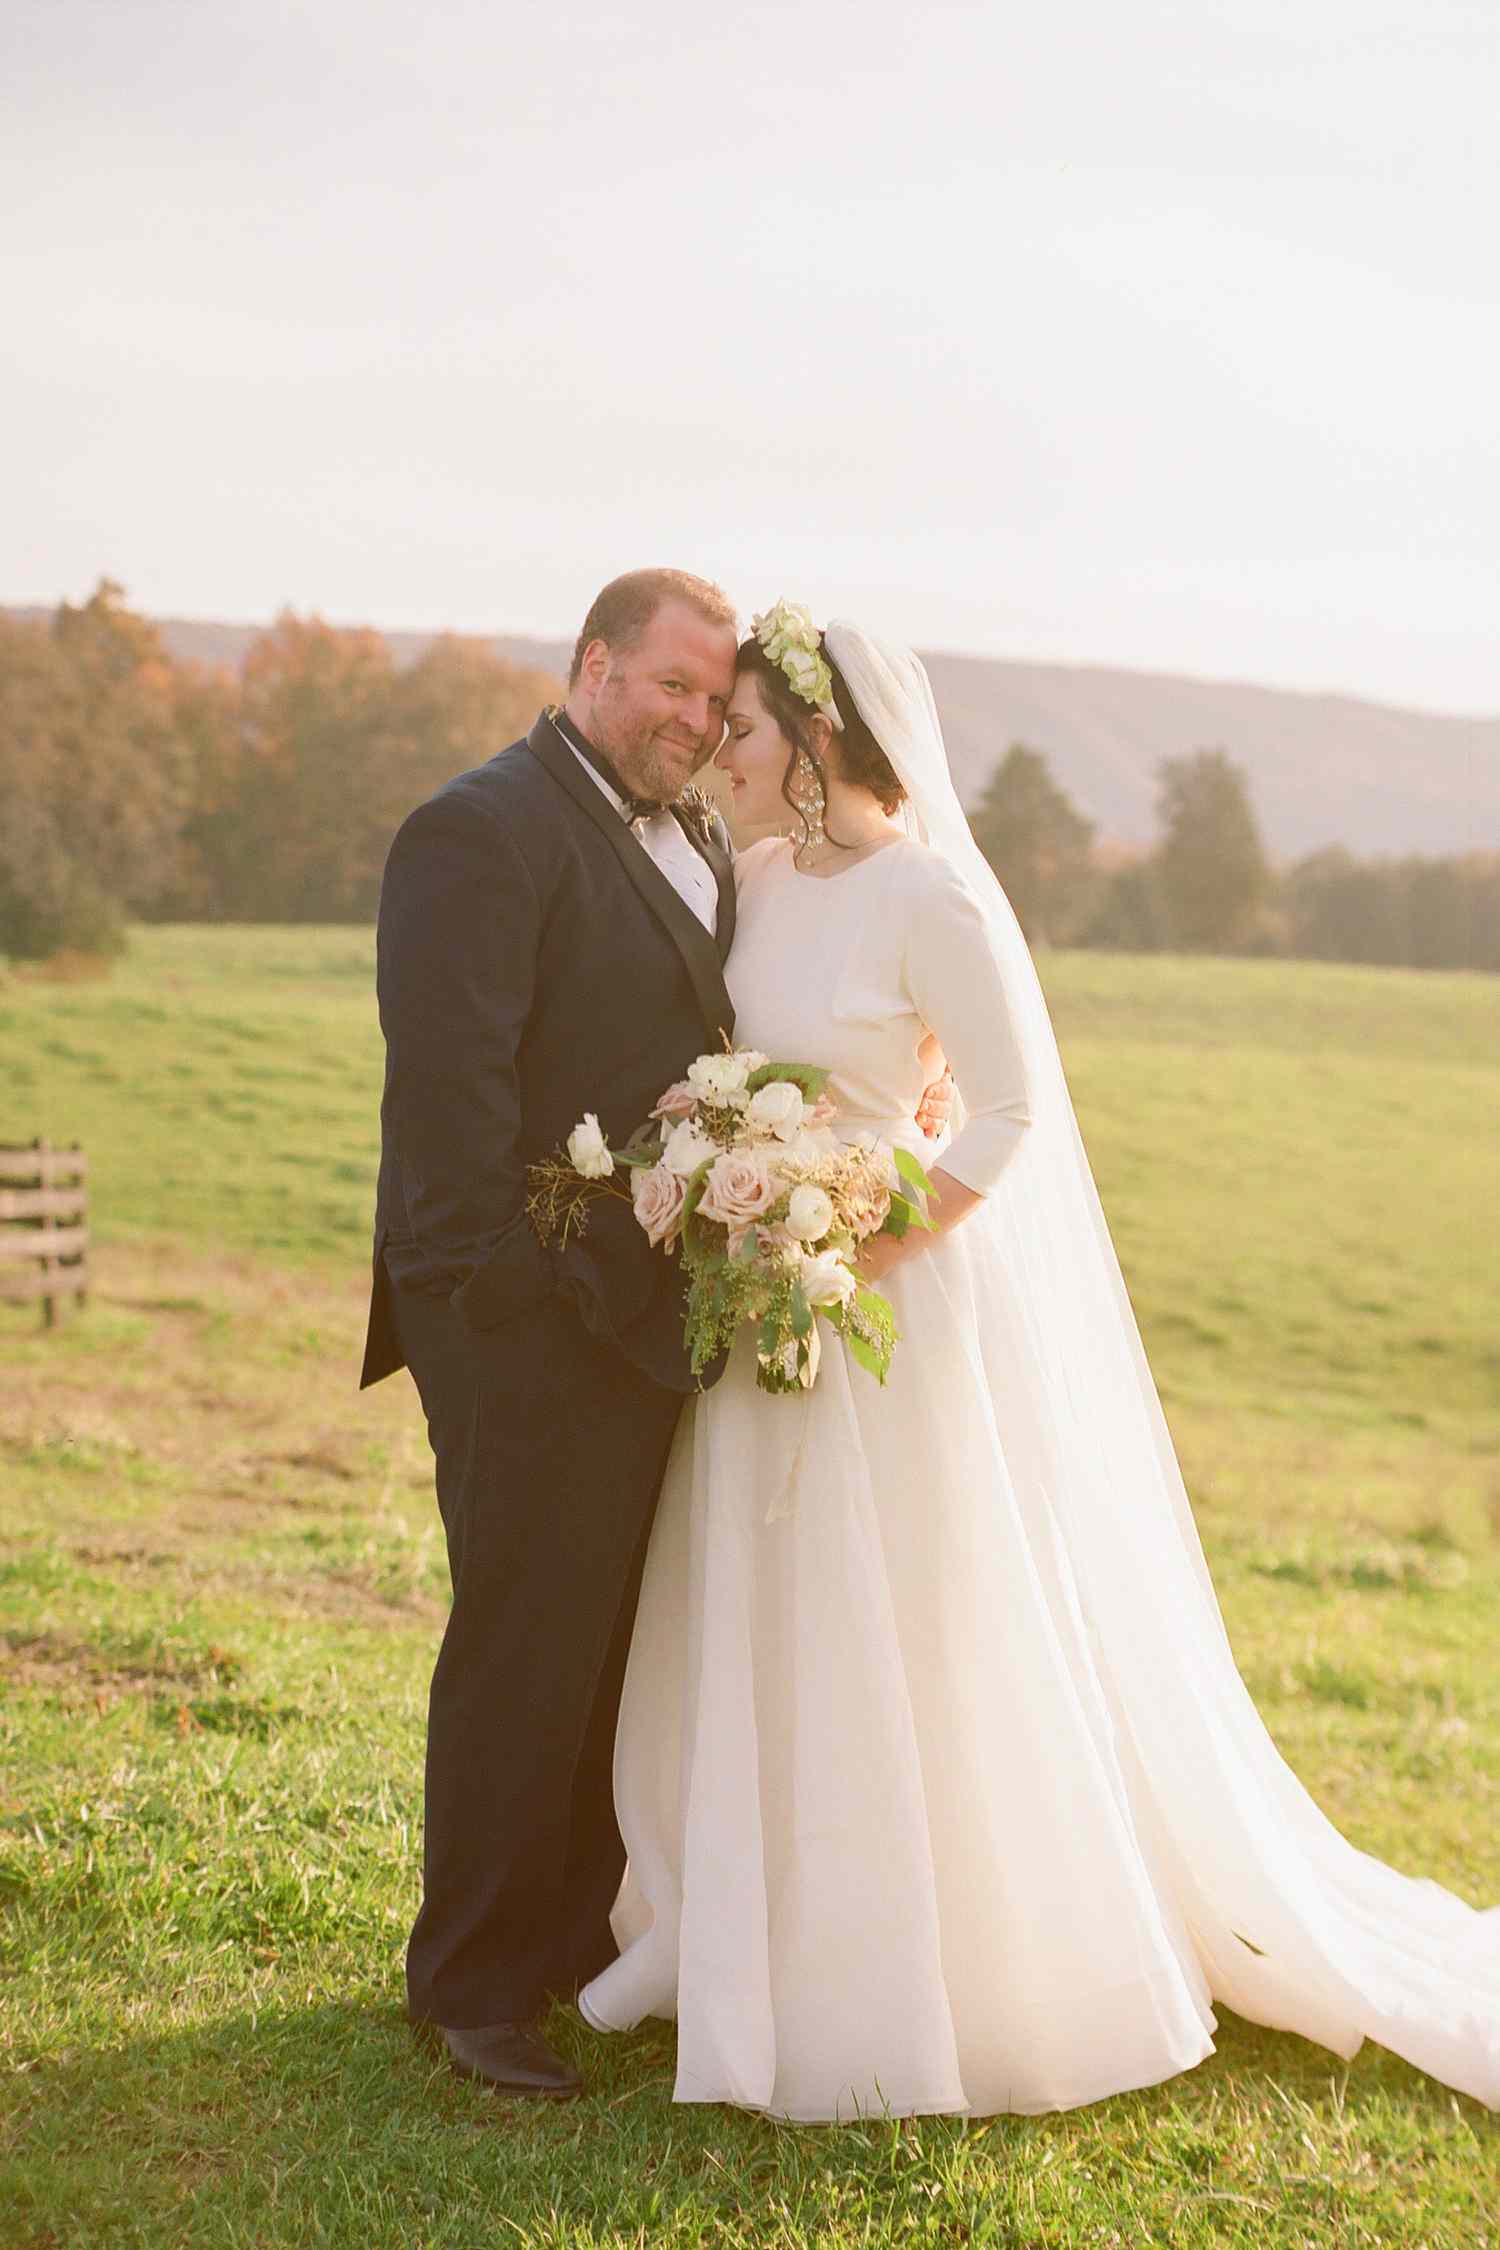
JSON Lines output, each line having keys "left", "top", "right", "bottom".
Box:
{"left": 0, "top": 581, "right": 1500, "bottom": 970}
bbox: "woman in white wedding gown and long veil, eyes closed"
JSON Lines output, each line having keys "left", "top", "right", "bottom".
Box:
{"left": 580, "top": 605, "right": 1500, "bottom": 2120}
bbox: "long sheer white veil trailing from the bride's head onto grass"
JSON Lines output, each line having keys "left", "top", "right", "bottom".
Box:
{"left": 823, "top": 621, "right": 1500, "bottom": 2106}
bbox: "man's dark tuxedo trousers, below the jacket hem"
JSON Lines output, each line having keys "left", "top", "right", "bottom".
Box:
{"left": 391, "top": 1287, "right": 681, "bottom": 2030}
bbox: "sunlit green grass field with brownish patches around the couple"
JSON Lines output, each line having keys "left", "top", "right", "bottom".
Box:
{"left": 0, "top": 929, "right": 1500, "bottom": 2250}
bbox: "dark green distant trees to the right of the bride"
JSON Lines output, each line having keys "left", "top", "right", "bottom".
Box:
{"left": 972, "top": 743, "right": 1500, "bottom": 970}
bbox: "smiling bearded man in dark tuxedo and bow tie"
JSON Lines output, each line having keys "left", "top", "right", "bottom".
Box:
{"left": 360, "top": 569, "right": 738, "bottom": 2095}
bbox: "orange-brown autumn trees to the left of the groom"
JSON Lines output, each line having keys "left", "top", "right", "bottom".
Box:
{"left": 0, "top": 581, "right": 558, "bottom": 961}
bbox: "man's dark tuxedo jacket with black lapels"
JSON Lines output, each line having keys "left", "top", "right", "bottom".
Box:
{"left": 360, "top": 713, "right": 735, "bottom": 1391}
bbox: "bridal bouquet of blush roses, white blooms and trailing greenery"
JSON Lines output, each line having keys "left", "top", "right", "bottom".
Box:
{"left": 526, "top": 1049, "right": 931, "bottom": 1393}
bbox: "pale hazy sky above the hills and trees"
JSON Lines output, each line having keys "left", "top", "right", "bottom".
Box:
{"left": 0, "top": 0, "right": 1500, "bottom": 711}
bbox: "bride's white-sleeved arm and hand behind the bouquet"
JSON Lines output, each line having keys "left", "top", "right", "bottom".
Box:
{"left": 859, "top": 862, "right": 1032, "bottom": 1280}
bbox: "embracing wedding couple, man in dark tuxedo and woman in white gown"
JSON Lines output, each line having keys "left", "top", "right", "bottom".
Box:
{"left": 362, "top": 572, "right": 1500, "bottom": 2120}
